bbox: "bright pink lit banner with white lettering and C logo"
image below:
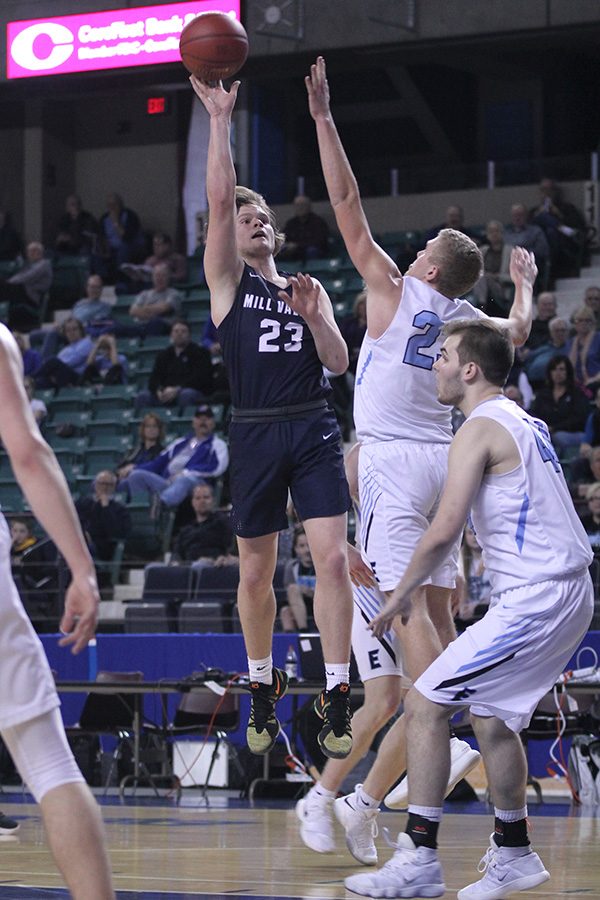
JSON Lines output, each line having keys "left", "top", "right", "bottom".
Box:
{"left": 6, "top": 0, "right": 240, "bottom": 79}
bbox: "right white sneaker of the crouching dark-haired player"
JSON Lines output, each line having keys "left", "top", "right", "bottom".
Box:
{"left": 457, "top": 835, "right": 550, "bottom": 900}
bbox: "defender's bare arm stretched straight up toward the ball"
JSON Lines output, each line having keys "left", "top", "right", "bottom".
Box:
{"left": 305, "top": 56, "right": 401, "bottom": 312}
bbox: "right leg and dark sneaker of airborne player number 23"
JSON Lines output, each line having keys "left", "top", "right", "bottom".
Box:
{"left": 304, "top": 515, "right": 353, "bottom": 759}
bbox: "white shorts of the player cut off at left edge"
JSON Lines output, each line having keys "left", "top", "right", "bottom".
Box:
{"left": 0, "top": 514, "right": 60, "bottom": 730}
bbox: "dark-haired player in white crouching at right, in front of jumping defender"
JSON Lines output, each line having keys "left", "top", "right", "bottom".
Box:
{"left": 345, "top": 322, "right": 593, "bottom": 900}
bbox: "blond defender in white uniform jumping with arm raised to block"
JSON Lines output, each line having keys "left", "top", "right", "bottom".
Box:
{"left": 306, "top": 57, "right": 537, "bottom": 861}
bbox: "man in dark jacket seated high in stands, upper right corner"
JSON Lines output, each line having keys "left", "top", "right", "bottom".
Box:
{"left": 529, "top": 178, "right": 587, "bottom": 278}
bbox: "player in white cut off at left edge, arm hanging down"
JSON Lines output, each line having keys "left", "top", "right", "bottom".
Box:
{"left": 0, "top": 325, "right": 115, "bottom": 900}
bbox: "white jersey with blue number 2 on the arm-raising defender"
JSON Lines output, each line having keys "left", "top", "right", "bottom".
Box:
{"left": 354, "top": 275, "right": 484, "bottom": 444}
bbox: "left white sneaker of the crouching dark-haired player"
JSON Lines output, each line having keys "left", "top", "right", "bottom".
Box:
{"left": 344, "top": 834, "right": 446, "bottom": 897}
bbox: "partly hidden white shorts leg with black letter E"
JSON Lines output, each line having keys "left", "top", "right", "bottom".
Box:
{"left": 352, "top": 585, "right": 403, "bottom": 682}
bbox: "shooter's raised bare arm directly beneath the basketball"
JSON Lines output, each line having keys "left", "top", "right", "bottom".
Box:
{"left": 190, "top": 75, "right": 244, "bottom": 326}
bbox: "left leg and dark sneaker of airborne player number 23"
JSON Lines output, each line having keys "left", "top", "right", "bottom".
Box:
{"left": 238, "top": 534, "right": 288, "bottom": 754}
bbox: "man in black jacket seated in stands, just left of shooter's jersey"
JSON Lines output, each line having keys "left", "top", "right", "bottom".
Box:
{"left": 136, "top": 319, "right": 213, "bottom": 409}
